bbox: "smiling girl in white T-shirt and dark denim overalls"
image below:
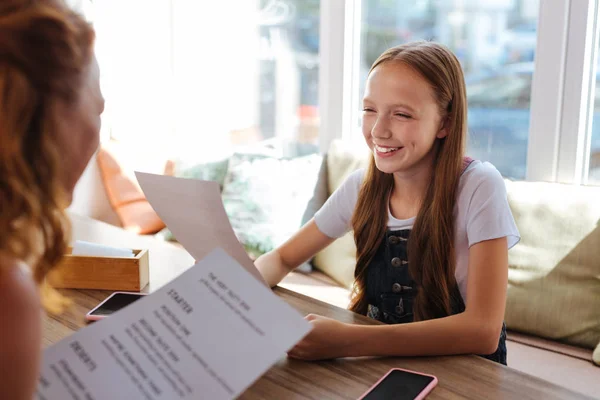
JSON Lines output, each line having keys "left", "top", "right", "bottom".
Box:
{"left": 256, "top": 42, "right": 519, "bottom": 364}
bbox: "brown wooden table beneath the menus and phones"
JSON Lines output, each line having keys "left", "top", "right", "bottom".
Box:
{"left": 43, "top": 215, "right": 587, "bottom": 400}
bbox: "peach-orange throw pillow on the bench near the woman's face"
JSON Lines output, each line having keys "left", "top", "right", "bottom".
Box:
{"left": 97, "top": 142, "right": 171, "bottom": 234}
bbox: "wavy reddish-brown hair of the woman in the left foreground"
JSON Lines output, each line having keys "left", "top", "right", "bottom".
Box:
{"left": 0, "top": 0, "right": 94, "bottom": 311}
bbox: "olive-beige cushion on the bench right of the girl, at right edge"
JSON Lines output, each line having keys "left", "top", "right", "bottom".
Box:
{"left": 506, "top": 181, "right": 600, "bottom": 348}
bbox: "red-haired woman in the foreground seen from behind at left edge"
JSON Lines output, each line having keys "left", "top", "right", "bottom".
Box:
{"left": 0, "top": 0, "right": 104, "bottom": 400}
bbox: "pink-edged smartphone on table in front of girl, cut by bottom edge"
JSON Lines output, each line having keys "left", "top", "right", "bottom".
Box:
{"left": 358, "top": 368, "right": 438, "bottom": 400}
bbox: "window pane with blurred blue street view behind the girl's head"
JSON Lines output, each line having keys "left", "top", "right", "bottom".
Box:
{"left": 359, "top": 0, "right": 539, "bottom": 179}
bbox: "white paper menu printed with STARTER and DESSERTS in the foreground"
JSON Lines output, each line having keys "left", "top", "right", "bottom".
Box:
{"left": 37, "top": 249, "right": 310, "bottom": 400}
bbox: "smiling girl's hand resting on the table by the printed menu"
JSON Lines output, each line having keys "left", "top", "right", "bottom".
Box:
{"left": 288, "top": 314, "right": 352, "bottom": 361}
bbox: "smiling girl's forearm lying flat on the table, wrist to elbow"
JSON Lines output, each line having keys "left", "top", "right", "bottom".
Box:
{"left": 347, "top": 312, "right": 500, "bottom": 357}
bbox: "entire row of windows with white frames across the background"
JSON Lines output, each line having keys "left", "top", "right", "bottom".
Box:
{"left": 89, "top": 0, "right": 600, "bottom": 184}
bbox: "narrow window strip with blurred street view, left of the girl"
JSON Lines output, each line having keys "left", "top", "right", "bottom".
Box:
{"left": 258, "top": 0, "right": 320, "bottom": 156}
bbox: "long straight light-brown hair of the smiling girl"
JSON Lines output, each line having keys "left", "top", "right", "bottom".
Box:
{"left": 350, "top": 42, "right": 467, "bottom": 321}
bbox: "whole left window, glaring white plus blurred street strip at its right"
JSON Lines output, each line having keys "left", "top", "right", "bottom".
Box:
{"left": 93, "top": 0, "right": 320, "bottom": 164}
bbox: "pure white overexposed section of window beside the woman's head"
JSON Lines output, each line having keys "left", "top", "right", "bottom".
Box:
{"left": 93, "top": 0, "right": 259, "bottom": 162}
